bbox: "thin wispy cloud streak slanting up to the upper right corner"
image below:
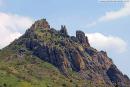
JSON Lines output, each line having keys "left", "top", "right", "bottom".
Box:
{"left": 87, "top": 2, "right": 130, "bottom": 27}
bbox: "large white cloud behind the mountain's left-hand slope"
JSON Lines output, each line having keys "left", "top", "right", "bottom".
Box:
{"left": 0, "top": 12, "right": 33, "bottom": 48}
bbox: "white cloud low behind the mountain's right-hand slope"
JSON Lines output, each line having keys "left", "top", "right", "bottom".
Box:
{"left": 86, "top": 33, "right": 127, "bottom": 53}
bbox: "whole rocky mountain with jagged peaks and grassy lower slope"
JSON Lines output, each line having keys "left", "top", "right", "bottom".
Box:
{"left": 0, "top": 19, "right": 130, "bottom": 87}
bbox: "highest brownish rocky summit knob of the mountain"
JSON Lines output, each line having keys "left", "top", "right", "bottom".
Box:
{"left": 31, "top": 19, "right": 50, "bottom": 30}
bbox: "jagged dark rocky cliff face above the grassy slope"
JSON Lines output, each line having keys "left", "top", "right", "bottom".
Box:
{"left": 1, "top": 19, "right": 130, "bottom": 87}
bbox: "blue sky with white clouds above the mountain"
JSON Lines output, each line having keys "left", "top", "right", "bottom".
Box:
{"left": 0, "top": 0, "right": 130, "bottom": 77}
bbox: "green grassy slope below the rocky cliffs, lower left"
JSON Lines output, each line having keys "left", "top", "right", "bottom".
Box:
{"left": 0, "top": 49, "right": 94, "bottom": 87}
